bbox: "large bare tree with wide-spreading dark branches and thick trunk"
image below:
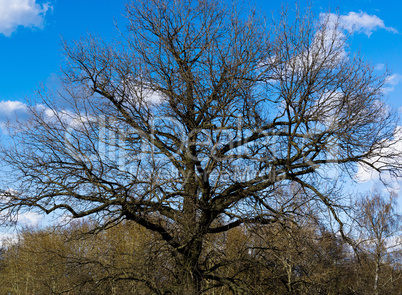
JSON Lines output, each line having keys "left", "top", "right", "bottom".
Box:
{"left": 1, "top": 0, "right": 400, "bottom": 294}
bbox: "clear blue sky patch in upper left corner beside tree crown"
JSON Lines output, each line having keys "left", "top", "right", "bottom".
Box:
{"left": 0, "top": 0, "right": 124, "bottom": 102}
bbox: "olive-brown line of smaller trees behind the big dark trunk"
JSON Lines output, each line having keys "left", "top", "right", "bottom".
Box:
{"left": 0, "top": 188, "right": 402, "bottom": 295}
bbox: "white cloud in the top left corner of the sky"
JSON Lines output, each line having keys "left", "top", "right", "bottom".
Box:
{"left": 0, "top": 0, "right": 52, "bottom": 37}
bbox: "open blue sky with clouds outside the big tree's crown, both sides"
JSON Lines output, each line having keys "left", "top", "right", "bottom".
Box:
{"left": 0, "top": 0, "right": 402, "bottom": 229}
